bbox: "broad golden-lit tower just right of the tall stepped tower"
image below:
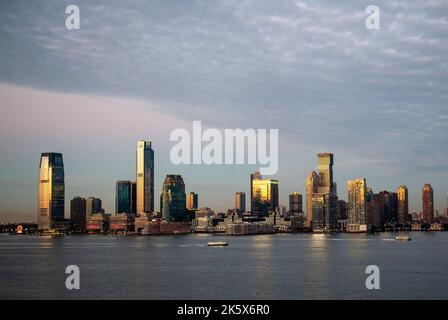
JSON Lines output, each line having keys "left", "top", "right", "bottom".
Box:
{"left": 347, "top": 178, "right": 367, "bottom": 232}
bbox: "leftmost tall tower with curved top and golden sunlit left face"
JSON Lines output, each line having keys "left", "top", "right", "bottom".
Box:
{"left": 37, "top": 152, "right": 65, "bottom": 230}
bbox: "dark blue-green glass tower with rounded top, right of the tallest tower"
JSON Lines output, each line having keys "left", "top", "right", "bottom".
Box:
{"left": 160, "top": 174, "right": 187, "bottom": 221}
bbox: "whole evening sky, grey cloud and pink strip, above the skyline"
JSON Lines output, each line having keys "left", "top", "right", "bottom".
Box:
{"left": 0, "top": 0, "right": 448, "bottom": 221}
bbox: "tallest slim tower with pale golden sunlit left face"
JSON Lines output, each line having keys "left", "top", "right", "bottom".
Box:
{"left": 136, "top": 140, "right": 154, "bottom": 216}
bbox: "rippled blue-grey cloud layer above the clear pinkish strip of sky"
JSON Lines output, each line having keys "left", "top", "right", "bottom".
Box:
{"left": 0, "top": 0, "right": 448, "bottom": 219}
